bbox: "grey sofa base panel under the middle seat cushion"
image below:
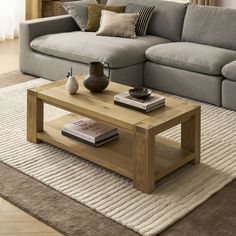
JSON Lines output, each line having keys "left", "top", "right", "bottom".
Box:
{"left": 144, "top": 62, "right": 223, "bottom": 106}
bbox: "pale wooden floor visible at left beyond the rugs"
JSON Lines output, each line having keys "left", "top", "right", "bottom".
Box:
{"left": 0, "top": 39, "right": 62, "bottom": 236}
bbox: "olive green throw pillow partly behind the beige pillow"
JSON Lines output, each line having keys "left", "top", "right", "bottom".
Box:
{"left": 84, "top": 4, "right": 125, "bottom": 32}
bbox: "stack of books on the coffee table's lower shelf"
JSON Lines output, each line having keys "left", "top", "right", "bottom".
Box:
{"left": 62, "top": 117, "right": 119, "bottom": 147}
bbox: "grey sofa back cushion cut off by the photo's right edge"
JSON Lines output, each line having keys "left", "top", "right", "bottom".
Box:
{"left": 182, "top": 4, "right": 236, "bottom": 50}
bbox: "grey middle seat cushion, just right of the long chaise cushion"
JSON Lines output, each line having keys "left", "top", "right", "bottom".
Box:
{"left": 146, "top": 42, "right": 236, "bottom": 75}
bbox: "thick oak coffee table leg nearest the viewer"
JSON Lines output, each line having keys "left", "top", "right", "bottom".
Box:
{"left": 133, "top": 127, "right": 155, "bottom": 193}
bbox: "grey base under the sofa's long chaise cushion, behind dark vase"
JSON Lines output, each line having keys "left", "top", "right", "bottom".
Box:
{"left": 20, "top": 50, "right": 143, "bottom": 87}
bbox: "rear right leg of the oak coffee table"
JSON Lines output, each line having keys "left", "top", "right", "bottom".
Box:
{"left": 181, "top": 108, "right": 201, "bottom": 164}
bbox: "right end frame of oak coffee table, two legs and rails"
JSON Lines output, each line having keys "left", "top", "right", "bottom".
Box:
{"left": 133, "top": 106, "right": 201, "bottom": 193}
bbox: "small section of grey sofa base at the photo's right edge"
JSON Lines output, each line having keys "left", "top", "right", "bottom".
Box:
{"left": 222, "top": 79, "right": 236, "bottom": 111}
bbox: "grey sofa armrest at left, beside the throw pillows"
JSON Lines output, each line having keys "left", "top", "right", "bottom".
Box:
{"left": 20, "top": 15, "right": 79, "bottom": 45}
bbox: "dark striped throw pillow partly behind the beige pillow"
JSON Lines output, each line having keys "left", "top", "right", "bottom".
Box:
{"left": 125, "top": 3, "right": 155, "bottom": 36}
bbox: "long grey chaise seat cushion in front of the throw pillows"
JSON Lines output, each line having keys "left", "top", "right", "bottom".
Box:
{"left": 30, "top": 31, "right": 170, "bottom": 68}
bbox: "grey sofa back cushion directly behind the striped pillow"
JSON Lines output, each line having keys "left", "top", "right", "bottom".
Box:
{"left": 107, "top": 0, "right": 188, "bottom": 41}
